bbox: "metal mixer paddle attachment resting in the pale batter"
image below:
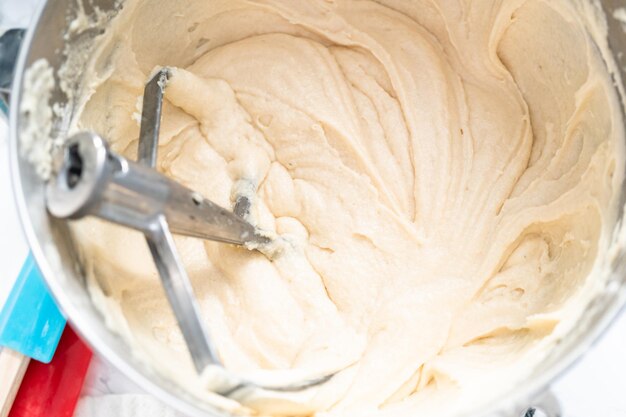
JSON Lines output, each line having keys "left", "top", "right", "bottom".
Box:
{"left": 46, "top": 69, "right": 332, "bottom": 396}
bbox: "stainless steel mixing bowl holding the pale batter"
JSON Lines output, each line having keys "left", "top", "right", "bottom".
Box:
{"left": 3, "top": 0, "right": 626, "bottom": 417}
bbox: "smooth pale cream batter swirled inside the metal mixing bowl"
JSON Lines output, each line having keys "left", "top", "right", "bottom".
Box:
{"left": 70, "top": 0, "right": 624, "bottom": 417}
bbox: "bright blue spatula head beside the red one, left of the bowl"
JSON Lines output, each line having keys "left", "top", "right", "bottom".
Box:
{"left": 0, "top": 253, "right": 65, "bottom": 363}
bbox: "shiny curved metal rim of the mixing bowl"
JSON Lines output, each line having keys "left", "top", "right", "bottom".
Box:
{"left": 8, "top": 0, "right": 626, "bottom": 417}
